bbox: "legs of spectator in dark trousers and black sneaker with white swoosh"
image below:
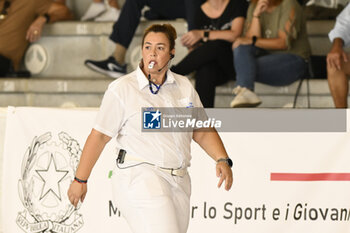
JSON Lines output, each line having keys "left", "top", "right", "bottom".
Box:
{"left": 85, "top": 0, "right": 202, "bottom": 78}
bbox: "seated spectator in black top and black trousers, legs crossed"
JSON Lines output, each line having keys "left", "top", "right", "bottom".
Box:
{"left": 172, "top": 0, "right": 248, "bottom": 108}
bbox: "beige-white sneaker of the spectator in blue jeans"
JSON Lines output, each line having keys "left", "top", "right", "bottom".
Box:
{"left": 230, "top": 86, "right": 261, "bottom": 108}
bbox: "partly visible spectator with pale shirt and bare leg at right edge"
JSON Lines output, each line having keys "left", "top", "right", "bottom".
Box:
{"left": 327, "top": 4, "right": 350, "bottom": 108}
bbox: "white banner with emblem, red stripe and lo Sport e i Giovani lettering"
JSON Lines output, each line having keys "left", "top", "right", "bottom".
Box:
{"left": 1, "top": 108, "right": 350, "bottom": 233}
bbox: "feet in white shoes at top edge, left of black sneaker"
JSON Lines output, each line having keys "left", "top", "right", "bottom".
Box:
{"left": 81, "top": 0, "right": 120, "bottom": 22}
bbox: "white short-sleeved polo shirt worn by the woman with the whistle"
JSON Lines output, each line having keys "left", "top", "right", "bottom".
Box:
{"left": 94, "top": 67, "right": 203, "bottom": 168}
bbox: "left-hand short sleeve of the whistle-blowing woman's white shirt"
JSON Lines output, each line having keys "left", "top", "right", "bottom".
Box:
{"left": 94, "top": 89, "right": 125, "bottom": 137}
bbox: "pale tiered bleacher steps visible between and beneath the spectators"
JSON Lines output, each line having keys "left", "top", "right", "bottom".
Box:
{"left": 0, "top": 0, "right": 348, "bottom": 108}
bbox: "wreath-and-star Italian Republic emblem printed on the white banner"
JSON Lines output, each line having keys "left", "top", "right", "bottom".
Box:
{"left": 16, "top": 132, "right": 84, "bottom": 233}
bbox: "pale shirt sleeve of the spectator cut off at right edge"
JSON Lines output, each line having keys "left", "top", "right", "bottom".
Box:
{"left": 328, "top": 3, "right": 350, "bottom": 47}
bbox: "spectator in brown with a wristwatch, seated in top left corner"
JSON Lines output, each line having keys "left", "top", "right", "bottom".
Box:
{"left": 0, "top": 0, "right": 72, "bottom": 77}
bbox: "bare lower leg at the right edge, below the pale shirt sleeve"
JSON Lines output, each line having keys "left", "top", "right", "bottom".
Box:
{"left": 327, "top": 54, "right": 350, "bottom": 108}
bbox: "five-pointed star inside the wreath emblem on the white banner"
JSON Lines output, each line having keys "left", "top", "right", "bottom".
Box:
{"left": 35, "top": 154, "right": 68, "bottom": 201}
